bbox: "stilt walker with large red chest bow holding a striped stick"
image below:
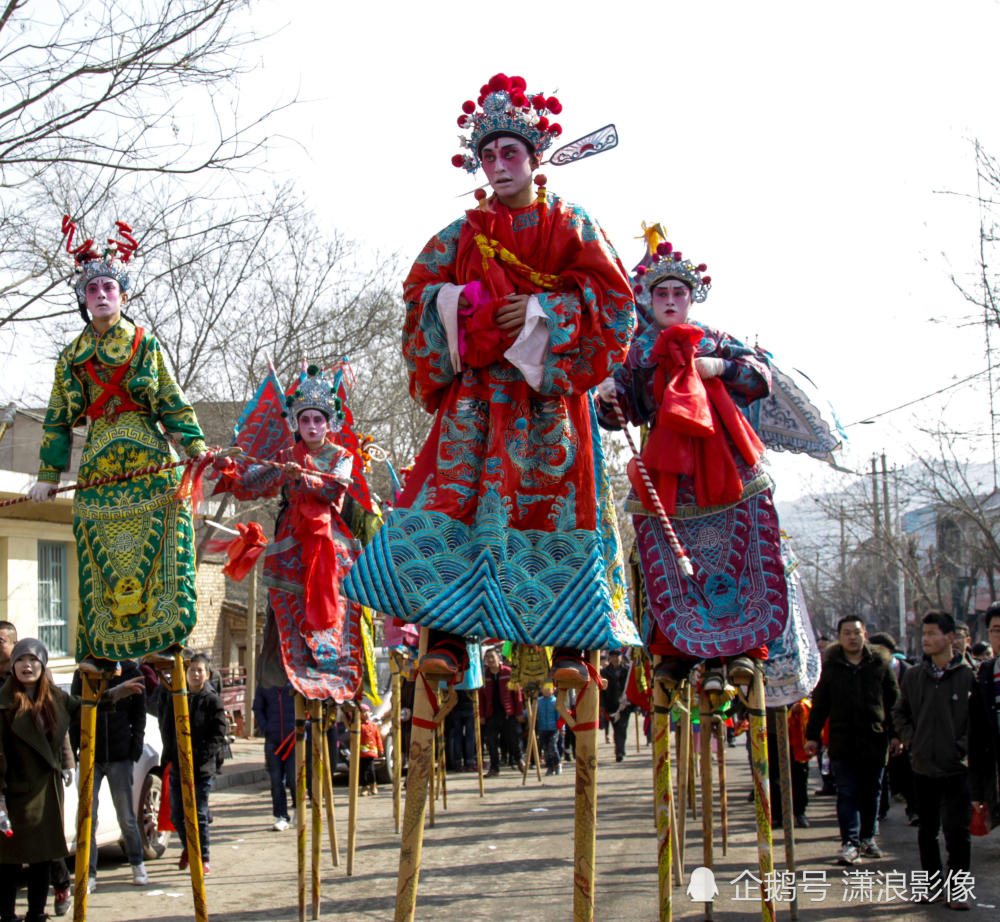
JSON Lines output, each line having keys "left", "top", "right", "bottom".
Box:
{"left": 598, "top": 226, "right": 788, "bottom": 918}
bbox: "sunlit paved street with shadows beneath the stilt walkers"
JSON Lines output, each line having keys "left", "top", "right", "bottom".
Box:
{"left": 80, "top": 740, "right": 1000, "bottom": 922}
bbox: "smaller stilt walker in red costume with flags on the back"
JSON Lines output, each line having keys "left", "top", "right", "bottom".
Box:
{"left": 216, "top": 366, "right": 367, "bottom": 920}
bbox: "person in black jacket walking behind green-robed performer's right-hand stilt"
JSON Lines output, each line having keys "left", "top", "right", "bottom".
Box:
{"left": 160, "top": 653, "right": 226, "bottom": 874}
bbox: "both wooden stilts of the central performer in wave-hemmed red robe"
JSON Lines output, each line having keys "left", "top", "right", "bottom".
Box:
{"left": 395, "top": 629, "right": 600, "bottom": 922}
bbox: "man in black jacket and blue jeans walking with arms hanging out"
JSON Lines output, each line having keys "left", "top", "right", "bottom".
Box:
{"left": 805, "top": 617, "right": 899, "bottom": 865}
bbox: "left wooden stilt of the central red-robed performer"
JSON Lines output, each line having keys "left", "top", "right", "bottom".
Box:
{"left": 394, "top": 628, "right": 436, "bottom": 922}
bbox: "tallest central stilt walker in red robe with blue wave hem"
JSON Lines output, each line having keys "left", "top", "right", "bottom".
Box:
{"left": 344, "top": 74, "right": 637, "bottom": 920}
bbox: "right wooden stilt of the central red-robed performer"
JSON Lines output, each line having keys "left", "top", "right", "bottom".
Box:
{"left": 556, "top": 650, "right": 601, "bottom": 922}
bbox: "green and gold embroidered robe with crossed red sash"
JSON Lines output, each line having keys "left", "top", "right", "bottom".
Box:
{"left": 38, "top": 318, "right": 205, "bottom": 661}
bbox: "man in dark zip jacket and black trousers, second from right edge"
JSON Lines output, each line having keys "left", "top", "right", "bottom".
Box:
{"left": 894, "top": 611, "right": 975, "bottom": 909}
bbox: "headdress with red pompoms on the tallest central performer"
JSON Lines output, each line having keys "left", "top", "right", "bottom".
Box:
{"left": 451, "top": 74, "right": 562, "bottom": 173}
